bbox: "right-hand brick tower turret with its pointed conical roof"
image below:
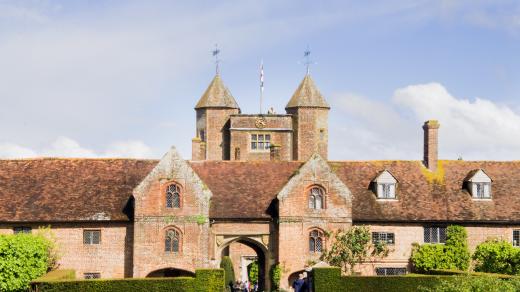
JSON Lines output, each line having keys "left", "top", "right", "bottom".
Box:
{"left": 285, "top": 74, "right": 330, "bottom": 160}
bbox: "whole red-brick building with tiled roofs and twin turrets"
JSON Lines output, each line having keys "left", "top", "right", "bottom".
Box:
{"left": 0, "top": 75, "right": 520, "bottom": 289}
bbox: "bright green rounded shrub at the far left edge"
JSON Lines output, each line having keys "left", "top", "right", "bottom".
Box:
{"left": 0, "top": 234, "right": 54, "bottom": 291}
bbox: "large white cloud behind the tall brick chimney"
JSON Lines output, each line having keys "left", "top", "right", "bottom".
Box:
{"left": 330, "top": 83, "right": 520, "bottom": 160}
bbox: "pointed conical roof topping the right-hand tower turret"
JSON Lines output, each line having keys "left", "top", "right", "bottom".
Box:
{"left": 285, "top": 74, "right": 330, "bottom": 109}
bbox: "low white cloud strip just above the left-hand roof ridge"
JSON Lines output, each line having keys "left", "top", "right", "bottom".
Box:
{"left": 0, "top": 137, "right": 156, "bottom": 158}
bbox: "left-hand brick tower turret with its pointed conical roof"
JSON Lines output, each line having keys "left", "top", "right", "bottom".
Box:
{"left": 192, "top": 73, "right": 240, "bottom": 160}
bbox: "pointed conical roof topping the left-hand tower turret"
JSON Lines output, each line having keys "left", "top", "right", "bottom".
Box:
{"left": 195, "top": 74, "right": 239, "bottom": 109}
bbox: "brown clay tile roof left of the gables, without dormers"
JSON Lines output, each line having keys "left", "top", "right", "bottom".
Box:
{"left": 0, "top": 158, "right": 157, "bottom": 222}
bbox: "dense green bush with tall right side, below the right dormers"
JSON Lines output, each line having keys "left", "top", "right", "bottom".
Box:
{"left": 411, "top": 225, "right": 471, "bottom": 272}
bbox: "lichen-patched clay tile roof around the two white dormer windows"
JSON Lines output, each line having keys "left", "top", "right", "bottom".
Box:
{"left": 330, "top": 161, "right": 520, "bottom": 222}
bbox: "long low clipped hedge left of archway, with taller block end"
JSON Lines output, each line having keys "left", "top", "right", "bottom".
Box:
{"left": 32, "top": 269, "right": 225, "bottom": 292}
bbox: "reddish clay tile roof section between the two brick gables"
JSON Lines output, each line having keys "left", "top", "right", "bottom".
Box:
{"left": 190, "top": 161, "right": 302, "bottom": 219}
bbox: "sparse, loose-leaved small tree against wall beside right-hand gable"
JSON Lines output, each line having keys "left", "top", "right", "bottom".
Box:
{"left": 321, "top": 226, "right": 388, "bottom": 274}
